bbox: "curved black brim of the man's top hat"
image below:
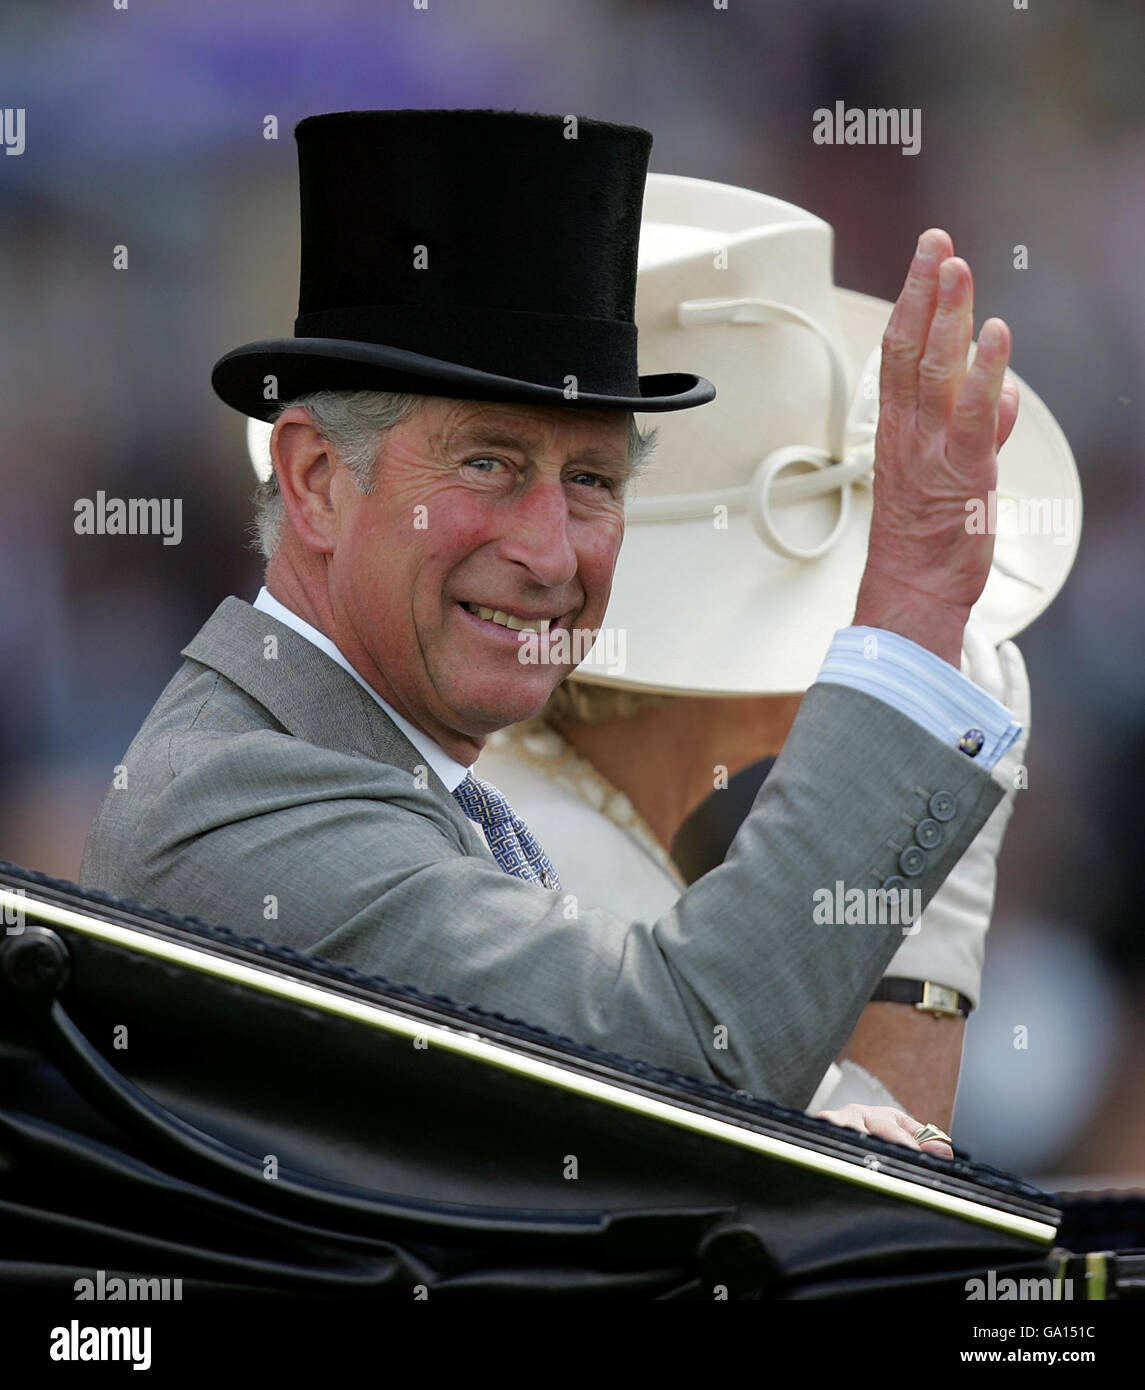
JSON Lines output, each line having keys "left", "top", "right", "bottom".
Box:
{"left": 211, "top": 338, "right": 716, "bottom": 421}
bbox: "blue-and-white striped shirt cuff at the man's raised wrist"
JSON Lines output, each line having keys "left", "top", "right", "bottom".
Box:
{"left": 818, "top": 627, "right": 1021, "bottom": 771}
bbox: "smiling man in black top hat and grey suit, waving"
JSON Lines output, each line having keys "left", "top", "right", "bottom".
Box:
{"left": 82, "top": 111, "right": 1017, "bottom": 1152}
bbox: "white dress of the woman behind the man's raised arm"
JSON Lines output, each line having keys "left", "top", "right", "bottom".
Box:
{"left": 474, "top": 719, "right": 902, "bottom": 1113}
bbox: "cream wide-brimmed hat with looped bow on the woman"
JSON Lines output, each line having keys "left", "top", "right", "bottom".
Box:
{"left": 247, "top": 174, "right": 1081, "bottom": 695}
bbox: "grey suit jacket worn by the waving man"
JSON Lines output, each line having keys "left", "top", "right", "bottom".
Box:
{"left": 81, "top": 598, "right": 1000, "bottom": 1106}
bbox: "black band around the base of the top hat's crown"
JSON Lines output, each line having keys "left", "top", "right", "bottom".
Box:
{"left": 295, "top": 304, "right": 641, "bottom": 399}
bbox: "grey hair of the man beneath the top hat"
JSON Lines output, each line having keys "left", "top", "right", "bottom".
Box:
{"left": 250, "top": 391, "right": 656, "bottom": 560}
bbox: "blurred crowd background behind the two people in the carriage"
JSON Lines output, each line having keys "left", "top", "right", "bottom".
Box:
{"left": 0, "top": 0, "right": 1145, "bottom": 1187}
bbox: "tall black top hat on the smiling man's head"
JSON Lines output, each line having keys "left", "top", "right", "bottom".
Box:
{"left": 211, "top": 111, "right": 716, "bottom": 420}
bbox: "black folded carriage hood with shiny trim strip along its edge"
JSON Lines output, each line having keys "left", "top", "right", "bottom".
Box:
{"left": 0, "top": 865, "right": 1145, "bottom": 1300}
